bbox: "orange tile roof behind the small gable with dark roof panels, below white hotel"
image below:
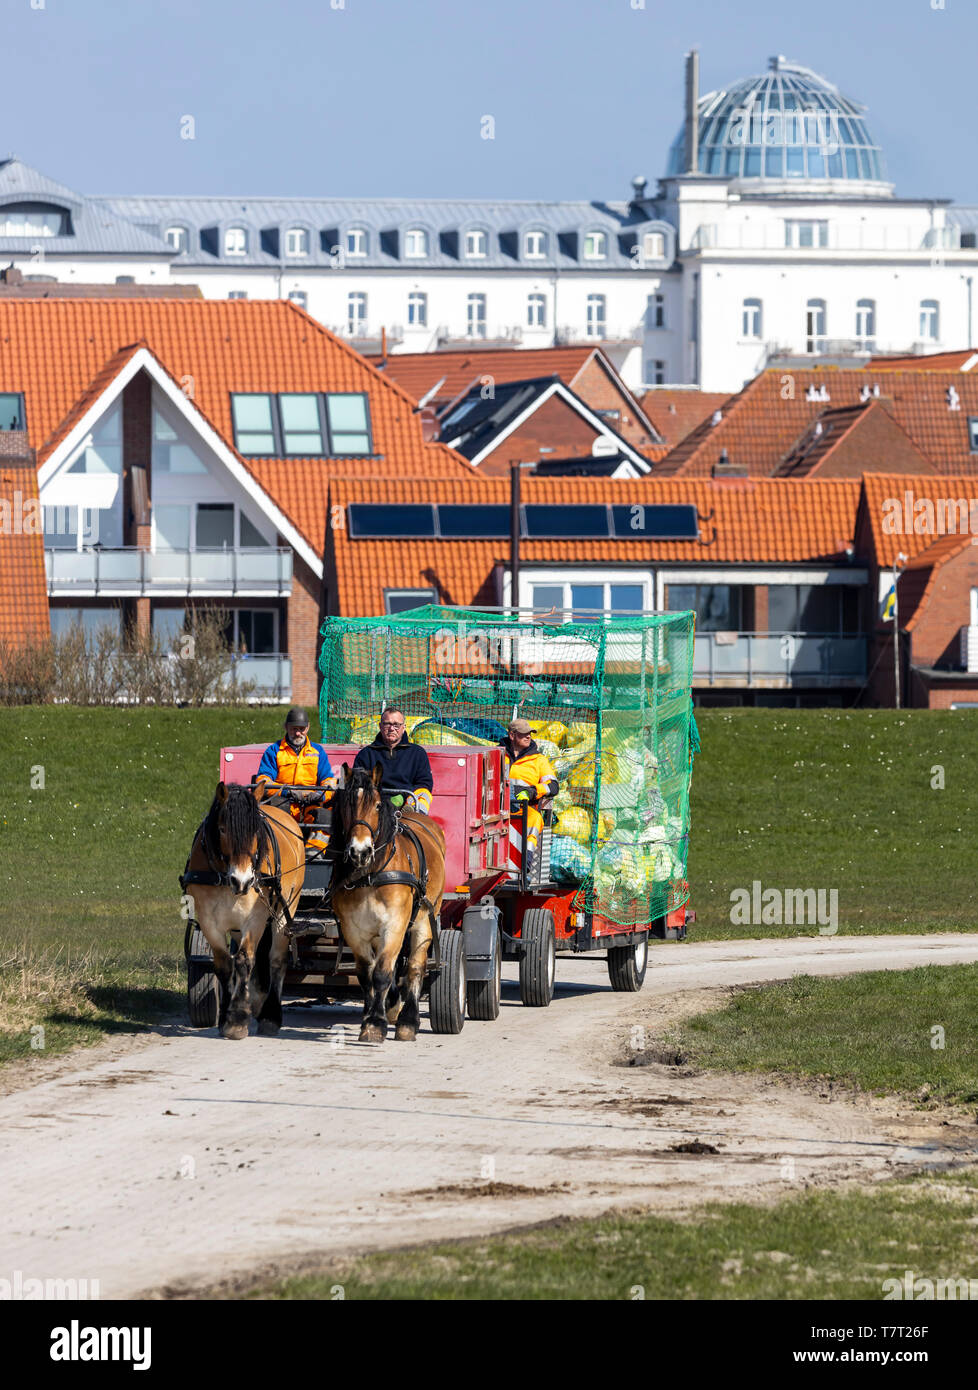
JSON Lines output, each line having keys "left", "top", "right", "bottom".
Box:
{"left": 368, "top": 346, "right": 595, "bottom": 404}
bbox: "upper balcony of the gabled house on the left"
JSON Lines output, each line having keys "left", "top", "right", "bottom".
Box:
{"left": 44, "top": 546, "right": 292, "bottom": 598}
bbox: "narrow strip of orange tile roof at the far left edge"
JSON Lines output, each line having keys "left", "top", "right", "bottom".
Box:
{"left": 0, "top": 457, "right": 51, "bottom": 646}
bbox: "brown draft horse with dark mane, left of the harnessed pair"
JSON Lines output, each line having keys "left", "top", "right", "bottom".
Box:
{"left": 181, "top": 783, "right": 306, "bottom": 1038}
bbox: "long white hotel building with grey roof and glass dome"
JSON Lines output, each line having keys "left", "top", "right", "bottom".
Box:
{"left": 0, "top": 54, "right": 978, "bottom": 391}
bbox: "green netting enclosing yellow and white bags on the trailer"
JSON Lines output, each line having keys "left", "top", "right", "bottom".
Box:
{"left": 320, "top": 606, "right": 699, "bottom": 926}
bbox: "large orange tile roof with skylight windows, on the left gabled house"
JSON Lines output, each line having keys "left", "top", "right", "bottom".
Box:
{"left": 0, "top": 299, "right": 471, "bottom": 552}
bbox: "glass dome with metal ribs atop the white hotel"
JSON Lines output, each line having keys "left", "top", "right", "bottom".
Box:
{"left": 668, "top": 57, "right": 890, "bottom": 193}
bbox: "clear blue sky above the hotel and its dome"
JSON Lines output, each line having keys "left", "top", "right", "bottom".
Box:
{"left": 0, "top": 0, "right": 978, "bottom": 203}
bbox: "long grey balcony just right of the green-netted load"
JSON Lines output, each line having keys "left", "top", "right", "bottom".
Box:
{"left": 693, "top": 632, "right": 867, "bottom": 689}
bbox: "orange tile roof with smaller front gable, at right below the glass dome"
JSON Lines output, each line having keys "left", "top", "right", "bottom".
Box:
{"left": 657, "top": 368, "right": 978, "bottom": 477}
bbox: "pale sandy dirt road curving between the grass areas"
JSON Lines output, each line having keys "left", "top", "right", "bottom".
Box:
{"left": 0, "top": 934, "right": 978, "bottom": 1298}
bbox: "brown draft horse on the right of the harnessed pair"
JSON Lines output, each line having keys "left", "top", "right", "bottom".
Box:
{"left": 329, "top": 763, "right": 445, "bottom": 1043}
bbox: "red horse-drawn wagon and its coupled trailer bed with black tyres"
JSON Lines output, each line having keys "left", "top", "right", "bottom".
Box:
{"left": 185, "top": 744, "right": 692, "bottom": 1033}
